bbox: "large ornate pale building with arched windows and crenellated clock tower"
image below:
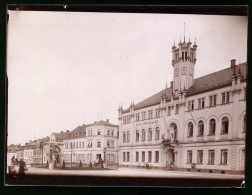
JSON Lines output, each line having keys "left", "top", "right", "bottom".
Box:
{"left": 118, "top": 37, "right": 247, "bottom": 173}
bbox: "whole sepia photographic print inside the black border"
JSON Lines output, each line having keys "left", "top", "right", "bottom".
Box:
{"left": 5, "top": 5, "right": 248, "bottom": 187}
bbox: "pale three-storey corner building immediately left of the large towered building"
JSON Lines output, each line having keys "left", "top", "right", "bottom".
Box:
{"left": 63, "top": 119, "right": 118, "bottom": 164}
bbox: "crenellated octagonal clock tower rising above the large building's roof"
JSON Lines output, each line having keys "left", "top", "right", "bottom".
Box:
{"left": 172, "top": 37, "right": 197, "bottom": 96}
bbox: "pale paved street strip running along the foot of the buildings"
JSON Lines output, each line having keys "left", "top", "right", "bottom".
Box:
{"left": 26, "top": 168, "right": 244, "bottom": 180}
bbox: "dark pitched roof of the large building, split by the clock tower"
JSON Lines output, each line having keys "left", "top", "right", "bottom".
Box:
{"left": 123, "top": 63, "right": 247, "bottom": 113}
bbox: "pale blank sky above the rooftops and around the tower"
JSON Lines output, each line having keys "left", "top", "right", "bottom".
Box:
{"left": 7, "top": 11, "right": 248, "bottom": 144}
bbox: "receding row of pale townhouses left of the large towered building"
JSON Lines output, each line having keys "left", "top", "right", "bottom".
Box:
{"left": 7, "top": 119, "right": 119, "bottom": 167}
